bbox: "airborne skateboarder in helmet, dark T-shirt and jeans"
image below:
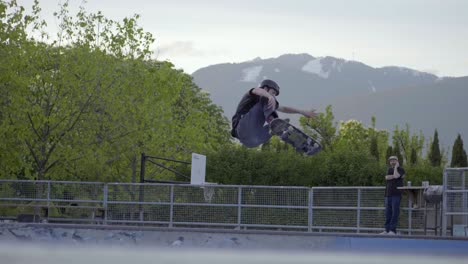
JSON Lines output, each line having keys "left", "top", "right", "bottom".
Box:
{"left": 231, "top": 79, "right": 317, "bottom": 155}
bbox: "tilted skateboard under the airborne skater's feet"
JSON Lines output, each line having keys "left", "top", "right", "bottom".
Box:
{"left": 270, "top": 118, "right": 322, "bottom": 156}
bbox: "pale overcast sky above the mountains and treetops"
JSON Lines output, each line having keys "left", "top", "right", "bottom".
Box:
{"left": 18, "top": 0, "right": 468, "bottom": 76}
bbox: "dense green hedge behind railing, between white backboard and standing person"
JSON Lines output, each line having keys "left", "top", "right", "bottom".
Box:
{"left": 207, "top": 141, "right": 386, "bottom": 186}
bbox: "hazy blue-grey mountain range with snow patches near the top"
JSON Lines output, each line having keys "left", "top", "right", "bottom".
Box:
{"left": 192, "top": 54, "right": 468, "bottom": 152}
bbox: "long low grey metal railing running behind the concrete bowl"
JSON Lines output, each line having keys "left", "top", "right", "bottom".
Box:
{"left": 0, "top": 180, "right": 434, "bottom": 234}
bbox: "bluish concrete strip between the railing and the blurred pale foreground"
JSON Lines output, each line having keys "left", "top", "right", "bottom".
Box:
{"left": 0, "top": 224, "right": 468, "bottom": 258}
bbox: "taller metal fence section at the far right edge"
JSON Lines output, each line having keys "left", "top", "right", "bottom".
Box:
{"left": 442, "top": 168, "right": 468, "bottom": 236}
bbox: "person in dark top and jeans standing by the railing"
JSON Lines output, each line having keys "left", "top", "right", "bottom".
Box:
{"left": 381, "top": 156, "right": 405, "bottom": 235}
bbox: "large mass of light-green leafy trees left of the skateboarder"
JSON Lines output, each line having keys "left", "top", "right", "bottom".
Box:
{"left": 0, "top": 1, "right": 231, "bottom": 181}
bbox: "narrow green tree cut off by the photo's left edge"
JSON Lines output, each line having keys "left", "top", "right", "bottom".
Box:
{"left": 0, "top": 1, "right": 49, "bottom": 179}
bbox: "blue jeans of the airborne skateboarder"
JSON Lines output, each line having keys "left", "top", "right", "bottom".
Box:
{"left": 237, "top": 98, "right": 276, "bottom": 148}
